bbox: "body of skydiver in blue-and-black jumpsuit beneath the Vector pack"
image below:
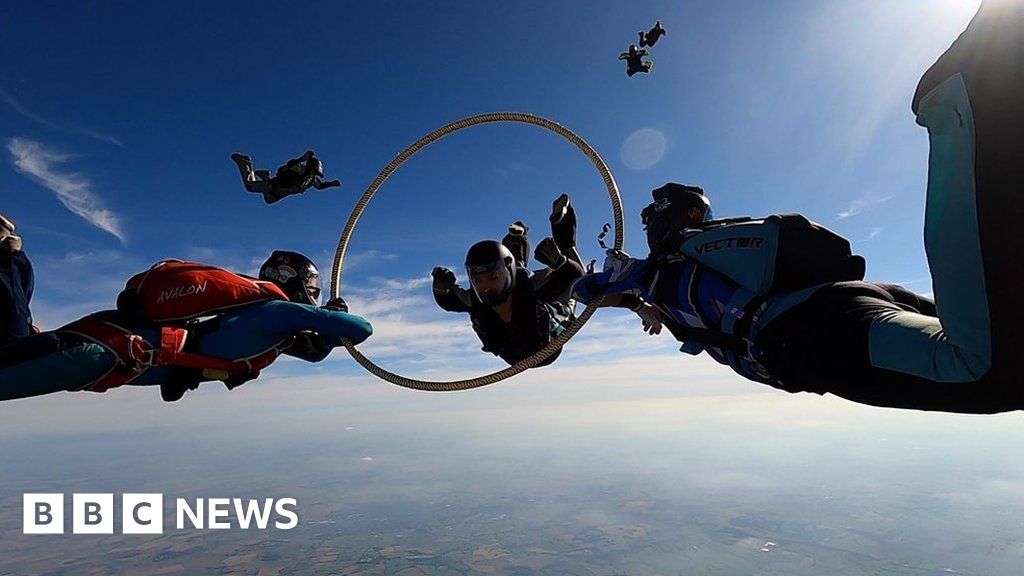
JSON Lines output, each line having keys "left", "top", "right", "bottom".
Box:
{"left": 573, "top": 0, "right": 1024, "bottom": 413}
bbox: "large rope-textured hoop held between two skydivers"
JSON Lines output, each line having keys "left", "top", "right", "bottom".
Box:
{"left": 331, "top": 112, "right": 626, "bottom": 392}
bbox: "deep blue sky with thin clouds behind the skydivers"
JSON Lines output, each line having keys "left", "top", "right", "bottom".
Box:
{"left": 0, "top": 0, "right": 978, "bottom": 400}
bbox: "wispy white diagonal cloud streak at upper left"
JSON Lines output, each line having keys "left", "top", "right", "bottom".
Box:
{"left": 7, "top": 138, "right": 125, "bottom": 243}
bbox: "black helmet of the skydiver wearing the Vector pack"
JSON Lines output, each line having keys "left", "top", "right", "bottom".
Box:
{"left": 640, "top": 182, "right": 712, "bottom": 255}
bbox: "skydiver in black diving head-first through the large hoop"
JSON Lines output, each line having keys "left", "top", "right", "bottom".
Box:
{"left": 432, "top": 194, "right": 584, "bottom": 365}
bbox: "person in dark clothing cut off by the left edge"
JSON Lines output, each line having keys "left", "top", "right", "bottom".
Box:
{"left": 0, "top": 214, "right": 35, "bottom": 345}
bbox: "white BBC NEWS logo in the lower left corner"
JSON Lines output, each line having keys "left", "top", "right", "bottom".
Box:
{"left": 23, "top": 494, "right": 299, "bottom": 534}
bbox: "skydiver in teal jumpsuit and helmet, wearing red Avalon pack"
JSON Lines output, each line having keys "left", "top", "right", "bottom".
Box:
{"left": 0, "top": 251, "right": 373, "bottom": 401}
